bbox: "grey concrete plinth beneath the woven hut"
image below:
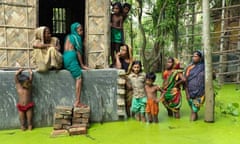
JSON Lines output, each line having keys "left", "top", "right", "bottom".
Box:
{"left": 0, "top": 69, "right": 118, "bottom": 129}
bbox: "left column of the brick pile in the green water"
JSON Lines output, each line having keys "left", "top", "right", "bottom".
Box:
{"left": 52, "top": 106, "right": 72, "bottom": 136}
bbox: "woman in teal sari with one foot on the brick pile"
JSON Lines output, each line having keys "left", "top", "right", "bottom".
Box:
{"left": 63, "top": 22, "right": 89, "bottom": 107}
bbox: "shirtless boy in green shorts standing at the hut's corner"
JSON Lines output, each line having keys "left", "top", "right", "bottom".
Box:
{"left": 111, "top": 2, "right": 123, "bottom": 64}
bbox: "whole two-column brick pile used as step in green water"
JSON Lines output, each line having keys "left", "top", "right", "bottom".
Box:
{"left": 52, "top": 106, "right": 90, "bottom": 137}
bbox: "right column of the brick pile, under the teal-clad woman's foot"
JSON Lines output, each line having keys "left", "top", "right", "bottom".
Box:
{"left": 69, "top": 106, "right": 90, "bottom": 135}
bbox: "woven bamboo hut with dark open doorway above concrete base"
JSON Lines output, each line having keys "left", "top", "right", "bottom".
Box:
{"left": 0, "top": 0, "right": 110, "bottom": 69}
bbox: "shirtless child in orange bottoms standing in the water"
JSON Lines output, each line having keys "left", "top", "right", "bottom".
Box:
{"left": 145, "top": 72, "right": 163, "bottom": 123}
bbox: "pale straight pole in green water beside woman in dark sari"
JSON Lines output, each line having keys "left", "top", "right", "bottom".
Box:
{"left": 202, "top": 0, "right": 215, "bottom": 122}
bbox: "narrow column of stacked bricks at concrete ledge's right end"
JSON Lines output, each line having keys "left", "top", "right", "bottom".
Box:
{"left": 117, "top": 70, "right": 127, "bottom": 120}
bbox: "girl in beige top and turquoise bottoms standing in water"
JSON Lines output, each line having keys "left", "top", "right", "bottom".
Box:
{"left": 127, "top": 61, "right": 147, "bottom": 122}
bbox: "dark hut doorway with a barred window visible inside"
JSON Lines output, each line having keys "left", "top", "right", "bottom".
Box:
{"left": 38, "top": 0, "right": 85, "bottom": 52}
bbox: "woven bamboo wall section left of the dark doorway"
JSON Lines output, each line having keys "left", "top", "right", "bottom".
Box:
{"left": 0, "top": 0, "right": 36, "bottom": 68}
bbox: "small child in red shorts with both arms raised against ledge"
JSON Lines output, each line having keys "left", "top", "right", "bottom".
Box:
{"left": 15, "top": 69, "right": 34, "bottom": 131}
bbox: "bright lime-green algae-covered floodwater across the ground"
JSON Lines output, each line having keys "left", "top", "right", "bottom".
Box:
{"left": 0, "top": 85, "right": 240, "bottom": 144}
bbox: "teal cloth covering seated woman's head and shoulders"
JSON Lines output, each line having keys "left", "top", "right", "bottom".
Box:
{"left": 68, "top": 22, "right": 83, "bottom": 55}
